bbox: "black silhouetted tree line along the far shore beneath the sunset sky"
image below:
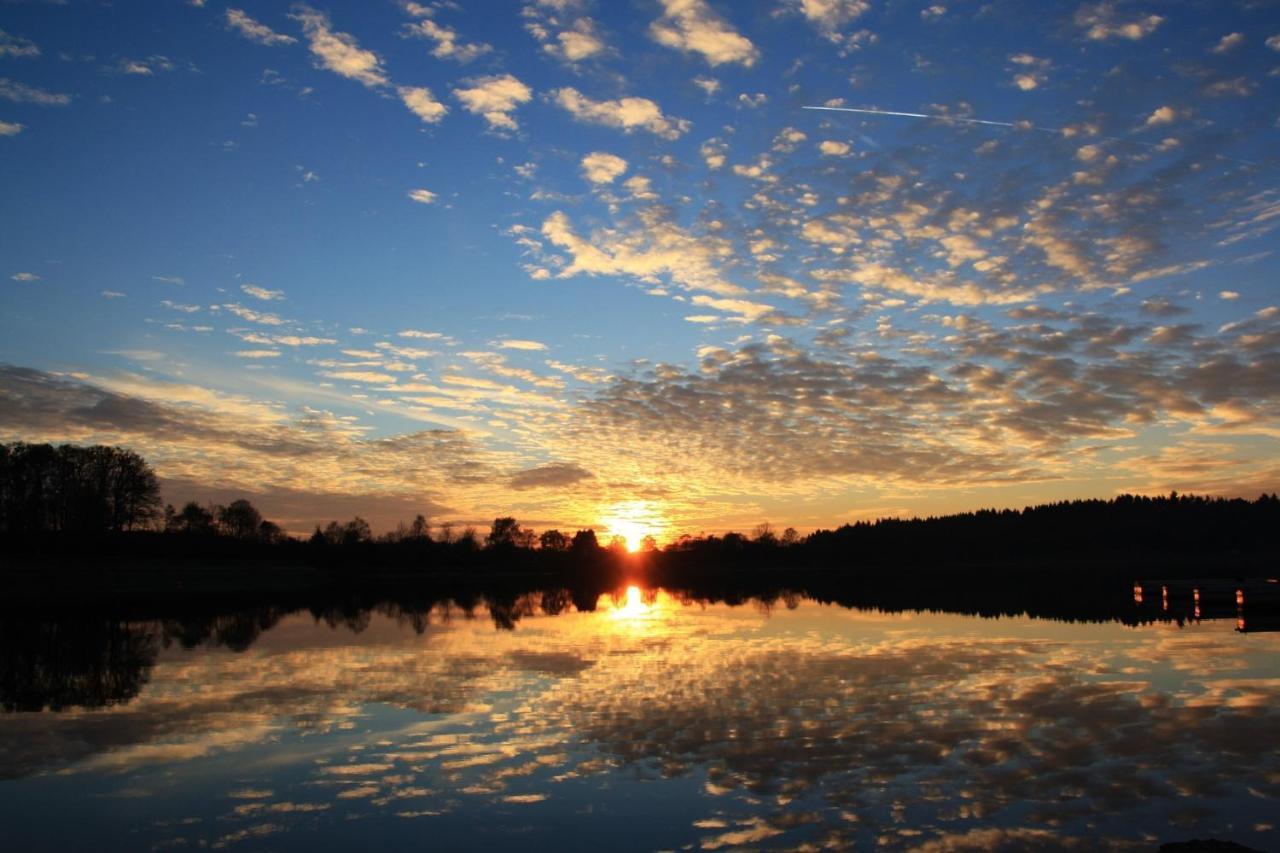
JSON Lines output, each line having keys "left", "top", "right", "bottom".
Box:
{"left": 0, "top": 443, "right": 1280, "bottom": 576}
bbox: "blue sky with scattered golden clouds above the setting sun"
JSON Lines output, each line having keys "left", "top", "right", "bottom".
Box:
{"left": 0, "top": 0, "right": 1280, "bottom": 540}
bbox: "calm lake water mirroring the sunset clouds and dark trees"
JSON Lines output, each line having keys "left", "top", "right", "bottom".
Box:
{"left": 0, "top": 581, "right": 1280, "bottom": 850}
